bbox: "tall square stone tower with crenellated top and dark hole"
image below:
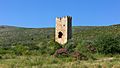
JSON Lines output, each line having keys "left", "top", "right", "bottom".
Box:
{"left": 55, "top": 16, "right": 72, "bottom": 45}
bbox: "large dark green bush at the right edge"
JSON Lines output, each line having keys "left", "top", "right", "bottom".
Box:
{"left": 94, "top": 34, "right": 120, "bottom": 54}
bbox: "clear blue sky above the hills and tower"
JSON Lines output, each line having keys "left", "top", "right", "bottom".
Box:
{"left": 0, "top": 0, "right": 120, "bottom": 28}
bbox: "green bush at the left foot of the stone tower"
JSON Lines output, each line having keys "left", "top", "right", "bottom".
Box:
{"left": 37, "top": 40, "right": 62, "bottom": 55}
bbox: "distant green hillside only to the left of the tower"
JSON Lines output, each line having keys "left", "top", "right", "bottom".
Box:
{"left": 0, "top": 27, "right": 54, "bottom": 45}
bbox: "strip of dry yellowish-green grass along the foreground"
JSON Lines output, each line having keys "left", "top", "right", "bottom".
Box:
{"left": 0, "top": 56, "right": 120, "bottom": 68}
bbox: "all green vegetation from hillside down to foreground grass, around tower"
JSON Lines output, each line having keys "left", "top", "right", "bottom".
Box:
{"left": 0, "top": 25, "right": 120, "bottom": 68}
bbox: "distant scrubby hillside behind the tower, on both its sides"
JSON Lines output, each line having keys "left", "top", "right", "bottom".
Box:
{"left": 0, "top": 26, "right": 120, "bottom": 46}
